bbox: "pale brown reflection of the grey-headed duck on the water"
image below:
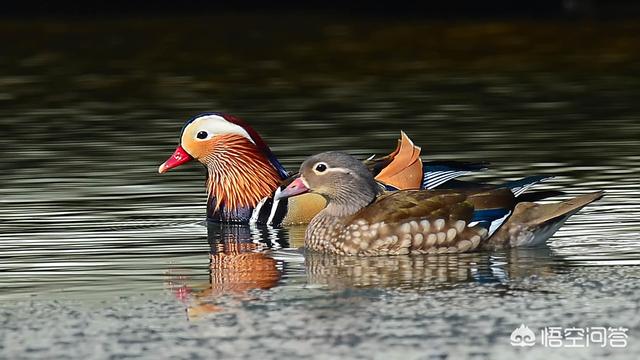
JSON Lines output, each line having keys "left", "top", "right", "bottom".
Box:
{"left": 305, "top": 245, "right": 557, "bottom": 291}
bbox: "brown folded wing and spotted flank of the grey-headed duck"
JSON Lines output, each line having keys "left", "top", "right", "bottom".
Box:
{"left": 346, "top": 189, "right": 513, "bottom": 255}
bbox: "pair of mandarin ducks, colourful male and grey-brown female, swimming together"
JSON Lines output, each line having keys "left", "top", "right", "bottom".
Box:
{"left": 158, "top": 113, "right": 603, "bottom": 256}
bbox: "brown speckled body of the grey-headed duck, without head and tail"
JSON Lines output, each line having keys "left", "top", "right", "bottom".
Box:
{"left": 305, "top": 191, "right": 496, "bottom": 256}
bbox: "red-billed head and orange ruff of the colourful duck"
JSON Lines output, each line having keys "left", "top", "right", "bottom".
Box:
{"left": 158, "top": 113, "right": 287, "bottom": 209}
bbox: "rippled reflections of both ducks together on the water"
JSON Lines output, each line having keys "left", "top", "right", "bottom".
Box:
{"left": 168, "top": 223, "right": 558, "bottom": 319}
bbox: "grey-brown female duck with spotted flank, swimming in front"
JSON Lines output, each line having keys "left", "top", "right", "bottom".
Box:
{"left": 276, "top": 152, "right": 602, "bottom": 256}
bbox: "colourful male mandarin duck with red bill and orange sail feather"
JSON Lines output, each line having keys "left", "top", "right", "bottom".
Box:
{"left": 158, "top": 113, "right": 485, "bottom": 225}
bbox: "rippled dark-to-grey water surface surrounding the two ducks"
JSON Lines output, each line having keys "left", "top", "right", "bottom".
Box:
{"left": 0, "top": 16, "right": 640, "bottom": 359}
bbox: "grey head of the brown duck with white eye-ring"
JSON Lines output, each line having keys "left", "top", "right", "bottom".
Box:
{"left": 278, "top": 151, "right": 381, "bottom": 216}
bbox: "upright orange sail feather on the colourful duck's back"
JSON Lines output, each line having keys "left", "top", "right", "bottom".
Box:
{"left": 375, "top": 131, "right": 422, "bottom": 190}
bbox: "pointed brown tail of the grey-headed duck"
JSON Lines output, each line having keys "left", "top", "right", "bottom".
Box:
{"left": 487, "top": 191, "right": 604, "bottom": 248}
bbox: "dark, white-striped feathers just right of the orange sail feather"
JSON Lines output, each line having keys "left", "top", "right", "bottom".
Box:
{"left": 422, "top": 161, "right": 489, "bottom": 190}
